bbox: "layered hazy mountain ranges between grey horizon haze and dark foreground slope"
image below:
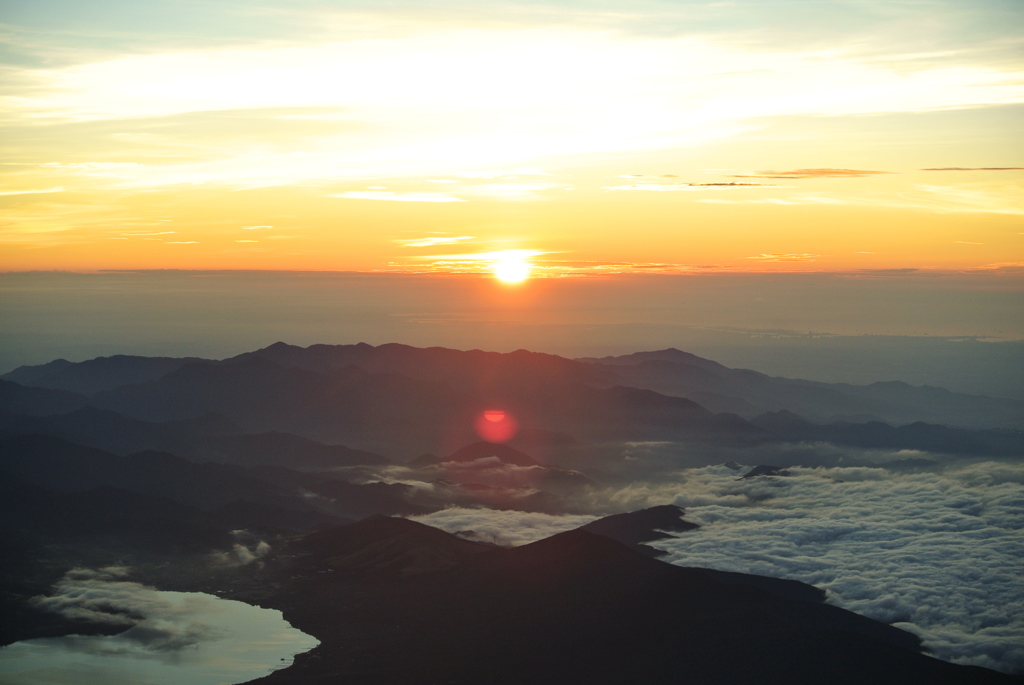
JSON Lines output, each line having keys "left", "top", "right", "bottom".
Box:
{"left": 0, "top": 343, "right": 1024, "bottom": 573}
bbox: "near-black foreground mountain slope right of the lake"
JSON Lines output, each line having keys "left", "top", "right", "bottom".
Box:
{"left": 239, "top": 517, "right": 1018, "bottom": 685}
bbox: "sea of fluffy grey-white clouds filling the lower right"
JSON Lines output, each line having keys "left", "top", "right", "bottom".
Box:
{"left": 652, "top": 462, "right": 1024, "bottom": 672}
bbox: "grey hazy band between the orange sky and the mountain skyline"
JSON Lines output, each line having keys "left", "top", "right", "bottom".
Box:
{"left": 0, "top": 271, "right": 1024, "bottom": 397}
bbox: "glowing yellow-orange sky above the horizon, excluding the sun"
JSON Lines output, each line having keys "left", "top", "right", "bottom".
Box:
{"left": 0, "top": 0, "right": 1024, "bottom": 274}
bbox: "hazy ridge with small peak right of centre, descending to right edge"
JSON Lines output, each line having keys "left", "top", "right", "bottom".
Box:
{"left": 579, "top": 348, "right": 1024, "bottom": 428}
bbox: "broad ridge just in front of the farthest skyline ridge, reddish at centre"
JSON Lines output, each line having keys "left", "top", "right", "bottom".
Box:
{"left": 93, "top": 346, "right": 770, "bottom": 455}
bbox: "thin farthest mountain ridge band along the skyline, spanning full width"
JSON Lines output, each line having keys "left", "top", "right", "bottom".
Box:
{"left": 3, "top": 343, "right": 1024, "bottom": 436}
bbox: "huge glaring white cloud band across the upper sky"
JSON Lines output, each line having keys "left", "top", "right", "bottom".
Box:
{"left": 8, "top": 25, "right": 1024, "bottom": 188}
